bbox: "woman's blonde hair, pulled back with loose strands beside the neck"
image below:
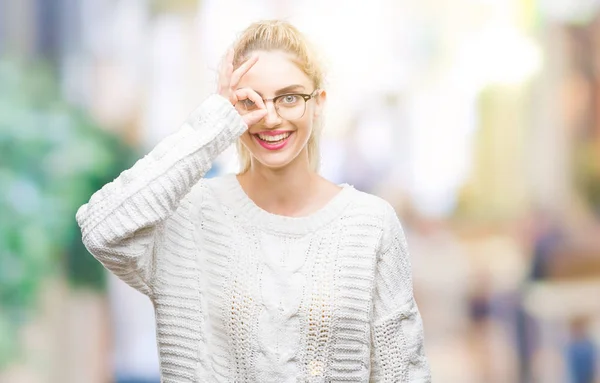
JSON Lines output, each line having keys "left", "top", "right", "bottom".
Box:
{"left": 233, "top": 20, "right": 324, "bottom": 173}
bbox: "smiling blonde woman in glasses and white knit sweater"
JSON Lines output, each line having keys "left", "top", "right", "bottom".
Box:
{"left": 77, "top": 21, "right": 431, "bottom": 383}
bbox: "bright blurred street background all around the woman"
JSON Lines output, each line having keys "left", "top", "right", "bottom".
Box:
{"left": 0, "top": 0, "right": 600, "bottom": 383}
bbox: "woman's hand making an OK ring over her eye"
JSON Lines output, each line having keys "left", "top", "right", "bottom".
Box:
{"left": 218, "top": 49, "right": 267, "bottom": 127}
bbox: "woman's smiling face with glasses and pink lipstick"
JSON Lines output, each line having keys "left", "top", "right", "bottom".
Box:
{"left": 238, "top": 51, "right": 325, "bottom": 169}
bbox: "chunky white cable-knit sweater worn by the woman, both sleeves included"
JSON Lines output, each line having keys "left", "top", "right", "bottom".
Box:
{"left": 77, "top": 95, "right": 431, "bottom": 383}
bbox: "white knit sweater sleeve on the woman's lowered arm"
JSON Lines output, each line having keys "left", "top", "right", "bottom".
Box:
{"left": 370, "top": 205, "right": 431, "bottom": 383}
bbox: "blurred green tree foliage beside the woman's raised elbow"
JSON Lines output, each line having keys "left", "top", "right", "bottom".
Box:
{"left": 0, "top": 59, "right": 136, "bottom": 369}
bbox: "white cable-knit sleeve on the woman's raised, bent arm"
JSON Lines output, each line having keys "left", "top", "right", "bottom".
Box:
{"left": 76, "top": 95, "right": 247, "bottom": 297}
